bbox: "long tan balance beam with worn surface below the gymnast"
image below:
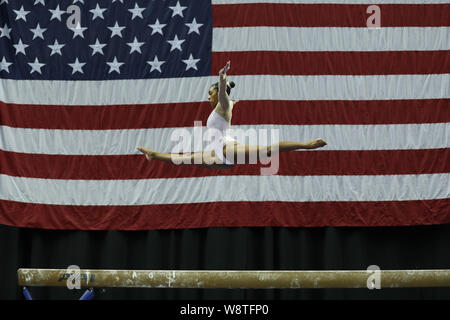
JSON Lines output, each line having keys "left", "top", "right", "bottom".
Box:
{"left": 17, "top": 268, "right": 450, "bottom": 289}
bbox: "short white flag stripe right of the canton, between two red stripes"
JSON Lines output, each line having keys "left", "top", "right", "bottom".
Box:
{"left": 212, "top": 27, "right": 450, "bottom": 52}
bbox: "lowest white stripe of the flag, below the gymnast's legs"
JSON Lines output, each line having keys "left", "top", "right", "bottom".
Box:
{"left": 0, "top": 174, "right": 450, "bottom": 205}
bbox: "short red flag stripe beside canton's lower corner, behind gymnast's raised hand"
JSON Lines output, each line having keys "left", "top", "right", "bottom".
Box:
{"left": 211, "top": 50, "right": 450, "bottom": 77}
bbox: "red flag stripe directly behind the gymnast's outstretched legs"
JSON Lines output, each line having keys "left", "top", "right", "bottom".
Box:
{"left": 0, "top": 148, "right": 450, "bottom": 180}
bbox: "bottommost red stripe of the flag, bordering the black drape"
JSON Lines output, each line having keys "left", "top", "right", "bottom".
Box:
{"left": 0, "top": 199, "right": 450, "bottom": 230}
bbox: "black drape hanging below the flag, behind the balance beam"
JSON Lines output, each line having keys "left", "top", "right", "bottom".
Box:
{"left": 0, "top": 225, "right": 450, "bottom": 299}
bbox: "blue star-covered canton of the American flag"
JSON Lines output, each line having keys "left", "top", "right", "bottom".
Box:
{"left": 0, "top": 0, "right": 212, "bottom": 80}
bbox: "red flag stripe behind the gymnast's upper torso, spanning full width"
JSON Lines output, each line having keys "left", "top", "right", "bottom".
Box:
{"left": 0, "top": 100, "right": 450, "bottom": 130}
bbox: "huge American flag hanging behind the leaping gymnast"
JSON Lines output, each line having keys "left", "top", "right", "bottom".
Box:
{"left": 0, "top": 0, "right": 450, "bottom": 230}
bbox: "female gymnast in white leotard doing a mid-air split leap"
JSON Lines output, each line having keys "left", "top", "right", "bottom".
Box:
{"left": 137, "top": 61, "right": 327, "bottom": 169}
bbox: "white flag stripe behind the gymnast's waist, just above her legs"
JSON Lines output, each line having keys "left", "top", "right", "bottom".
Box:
{"left": 0, "top": 123, "right": 450, "bottom": 155}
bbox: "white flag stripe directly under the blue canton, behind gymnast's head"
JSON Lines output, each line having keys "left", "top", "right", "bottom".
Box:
{"left": 0, "top": 74, "right": 450, "bottom": 105}
